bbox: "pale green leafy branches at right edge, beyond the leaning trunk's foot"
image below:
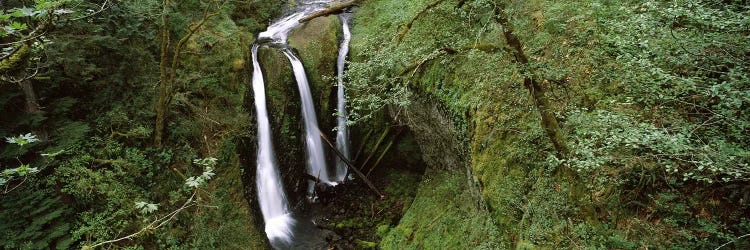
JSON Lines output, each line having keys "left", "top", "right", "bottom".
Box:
{"left": 565, "top": 110, "right": 750, "bottom": 186}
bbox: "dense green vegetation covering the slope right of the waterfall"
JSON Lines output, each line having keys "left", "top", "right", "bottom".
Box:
{"left": 349, "top": 0, "right": 750, "bottom": 249}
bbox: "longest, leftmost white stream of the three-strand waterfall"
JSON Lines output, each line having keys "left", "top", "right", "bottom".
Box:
{"left": 252, "top": 44, "right": 294, "bottom": 242}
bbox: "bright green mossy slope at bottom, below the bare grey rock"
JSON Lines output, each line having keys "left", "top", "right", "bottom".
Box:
{"left": 380, "top": 172, "right": 503, "bottom": 249}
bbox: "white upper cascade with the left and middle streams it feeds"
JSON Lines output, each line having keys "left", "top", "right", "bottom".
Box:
{"left": 252, "top": 0, "right": 336, "bottom": 246}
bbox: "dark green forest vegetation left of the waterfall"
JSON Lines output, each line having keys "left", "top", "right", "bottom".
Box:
{"left": 0, "top": 0, "right": 279, "bottom": 249}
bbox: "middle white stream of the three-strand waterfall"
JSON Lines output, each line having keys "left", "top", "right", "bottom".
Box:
{"left": 283, "top": 49, "right": 336, "bottom": 193}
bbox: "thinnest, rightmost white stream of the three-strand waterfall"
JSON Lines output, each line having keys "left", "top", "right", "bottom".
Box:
{"left": 336, "top": 16, "right": 352, "bottom": 181}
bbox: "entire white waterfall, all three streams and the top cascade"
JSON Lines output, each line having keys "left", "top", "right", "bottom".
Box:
{"left": 251, "top": 0, "right": 351, "bottom": 249}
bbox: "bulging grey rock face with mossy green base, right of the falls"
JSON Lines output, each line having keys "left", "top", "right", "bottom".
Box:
{"left": 379, "top": 93, "right": 504, "bottom": 249}
